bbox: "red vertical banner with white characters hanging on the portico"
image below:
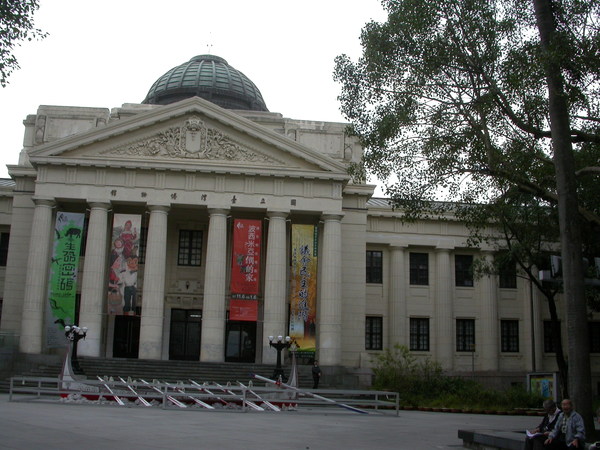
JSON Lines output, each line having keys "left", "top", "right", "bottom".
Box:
{"left": 229, "top": 219, "right": 262, "bottom": 322}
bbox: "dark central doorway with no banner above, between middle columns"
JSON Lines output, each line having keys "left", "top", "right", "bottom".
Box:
{"left": 169, "top": 309, "right": 202, "bottom": 361}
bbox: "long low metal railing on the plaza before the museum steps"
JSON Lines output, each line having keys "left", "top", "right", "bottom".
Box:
{"left": 9, "top": 376, "right": 400, "bottom": 415}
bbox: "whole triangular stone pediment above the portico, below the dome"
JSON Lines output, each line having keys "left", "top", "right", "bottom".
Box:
{"left": 29, "top": 97, "right": 346, "bottom": 177}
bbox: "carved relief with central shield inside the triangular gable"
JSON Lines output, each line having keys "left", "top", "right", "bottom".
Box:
{"left": 102, "top": 116, "right": 285, "bottom": 165}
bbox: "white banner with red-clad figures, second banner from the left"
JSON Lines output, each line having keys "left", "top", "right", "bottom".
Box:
{"left": 108, "top": 214, "right": 142, "bottom": 316}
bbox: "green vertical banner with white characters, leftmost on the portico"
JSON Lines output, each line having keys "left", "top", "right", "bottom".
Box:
{"left": 46, "top": 211, "right": 85, "bottom": 348}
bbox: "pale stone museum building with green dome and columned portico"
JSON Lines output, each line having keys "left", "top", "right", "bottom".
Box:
{"left": 0, "top": 55, "right": 600, "bottom": 383}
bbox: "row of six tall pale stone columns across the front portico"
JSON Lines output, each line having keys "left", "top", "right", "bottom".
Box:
{"left": 20, "top": 198, "right": 342, "bottom": 365}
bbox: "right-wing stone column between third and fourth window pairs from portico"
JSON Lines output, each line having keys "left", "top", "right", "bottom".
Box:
{"left": 475, "top": 252, "right": 500, "bottom": 371}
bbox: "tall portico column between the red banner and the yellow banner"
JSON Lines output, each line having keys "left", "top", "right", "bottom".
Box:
{"left": 262, "top": 211, "right": 288, "bottom": 364}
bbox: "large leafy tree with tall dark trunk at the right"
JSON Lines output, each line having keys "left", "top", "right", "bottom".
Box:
{"left": 335, "top": 0, "right": 600, "bottom": 425}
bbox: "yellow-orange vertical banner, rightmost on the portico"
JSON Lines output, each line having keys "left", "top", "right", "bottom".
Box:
{"left": 290, "top": 224, "right": 318, "bottom": 358}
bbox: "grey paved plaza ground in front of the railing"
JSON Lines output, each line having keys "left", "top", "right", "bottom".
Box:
{"left": 0, "top": 394, "right": 539, "bottom": 450}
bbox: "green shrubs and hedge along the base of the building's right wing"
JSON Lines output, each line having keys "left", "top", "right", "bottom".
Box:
{"left": 373, "top": 345, "right": 543, "bottom": 411}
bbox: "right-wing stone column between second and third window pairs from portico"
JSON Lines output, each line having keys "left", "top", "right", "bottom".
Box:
{"left": 434, "top": 248, "right": 456, "bottom": 370}
